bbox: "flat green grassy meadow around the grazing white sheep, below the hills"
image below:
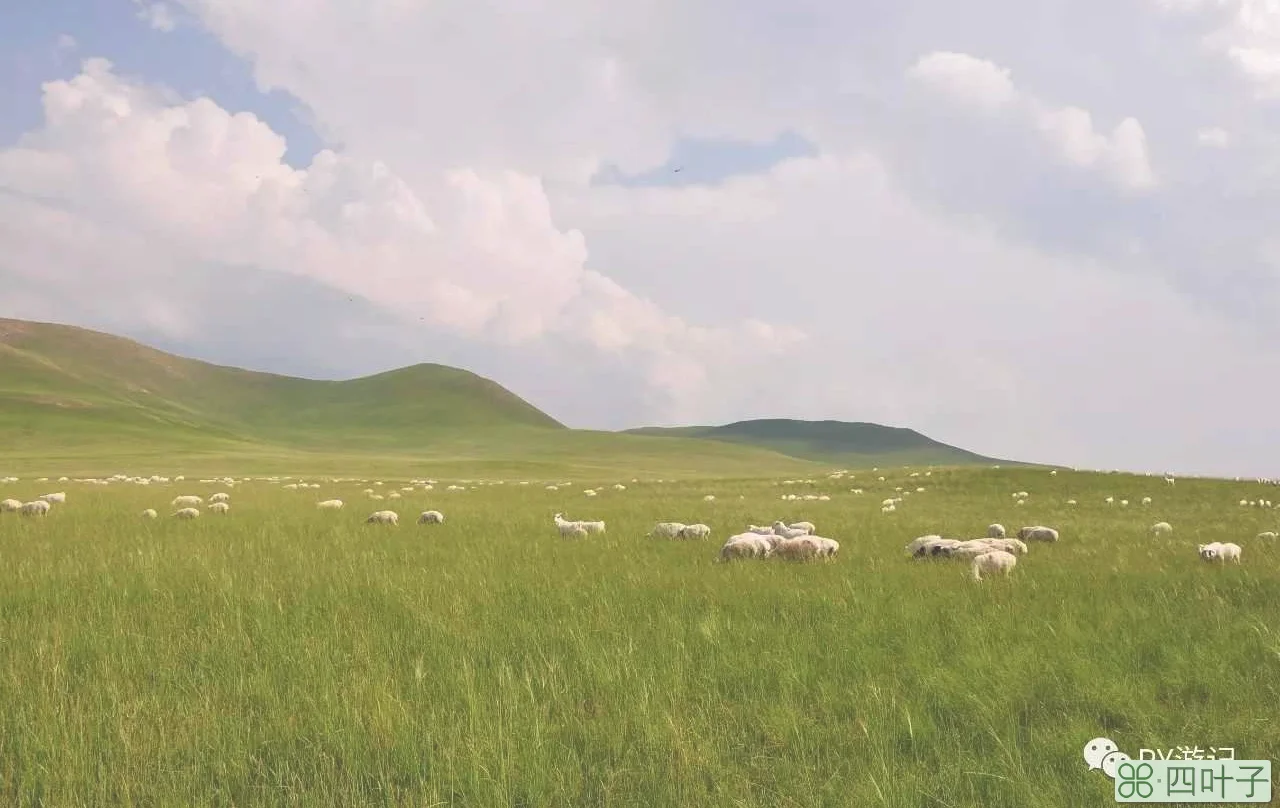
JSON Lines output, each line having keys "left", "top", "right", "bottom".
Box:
{"left": 0, "top": 469, "right": 1280, "bottom": 808}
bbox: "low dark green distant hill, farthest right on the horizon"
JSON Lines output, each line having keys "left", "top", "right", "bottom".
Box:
{"left": 626, "top": 419, "right": 1021, "bottom": 466}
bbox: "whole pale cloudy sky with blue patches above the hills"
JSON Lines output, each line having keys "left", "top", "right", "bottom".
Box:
{"left": 0, "top": 0, "right": 1280, "bottom": 476}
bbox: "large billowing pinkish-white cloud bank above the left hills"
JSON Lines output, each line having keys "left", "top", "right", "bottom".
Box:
{"left": 0, "top": 59, "right": 804, "bottom": 417}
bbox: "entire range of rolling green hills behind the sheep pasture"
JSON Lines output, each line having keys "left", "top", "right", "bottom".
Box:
{"left": 0, "top": 319, "right": 1018, "bottom": 476}
